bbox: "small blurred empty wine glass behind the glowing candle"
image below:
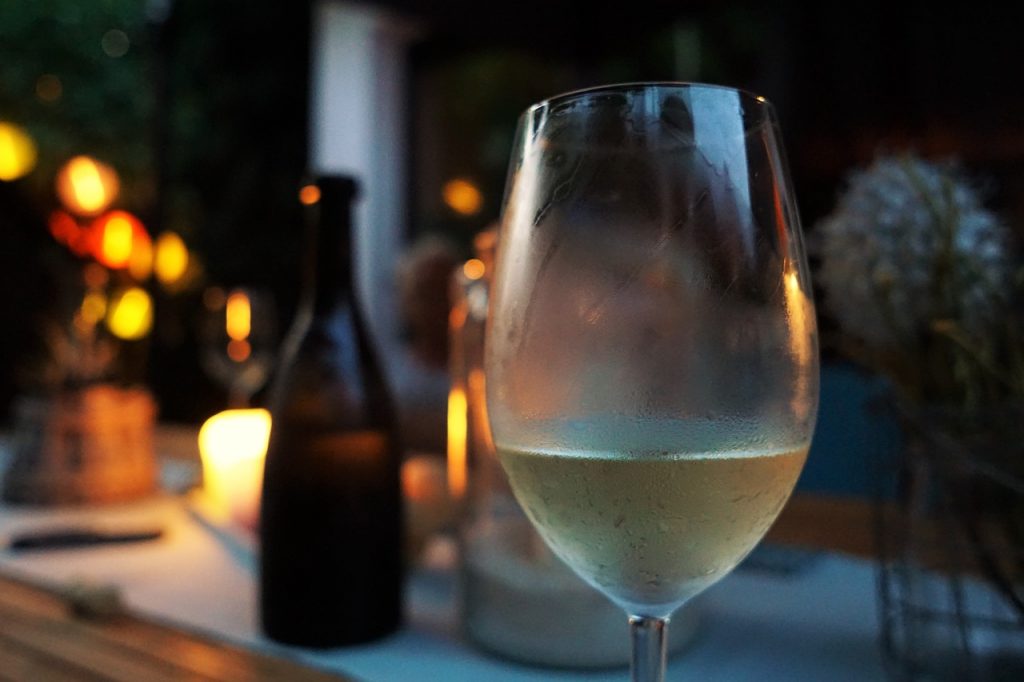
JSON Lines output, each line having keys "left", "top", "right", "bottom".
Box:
{"left": 200, "top": 287, "right": 278, "bottom": 408}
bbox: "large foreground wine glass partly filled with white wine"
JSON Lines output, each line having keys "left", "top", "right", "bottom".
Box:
{"left": 485, "top": 83, "right": 818, "bottom": 681}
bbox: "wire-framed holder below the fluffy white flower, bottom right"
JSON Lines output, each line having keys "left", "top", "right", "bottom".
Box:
{"left": 878, "top": 409, "right": 1024, "bottom": 682}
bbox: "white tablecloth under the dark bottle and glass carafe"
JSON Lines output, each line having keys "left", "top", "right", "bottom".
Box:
{"left": 0, "top": 483, "right": 885, "bottom": 682}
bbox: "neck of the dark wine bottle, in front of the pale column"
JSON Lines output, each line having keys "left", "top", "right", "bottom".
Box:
{"left": 306, "top": 176, "right": 357, "bottom": 315}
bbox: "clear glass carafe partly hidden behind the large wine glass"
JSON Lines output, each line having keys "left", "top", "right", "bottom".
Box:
{"left": 449, "top": 229, "right": 696, "bottom": 669}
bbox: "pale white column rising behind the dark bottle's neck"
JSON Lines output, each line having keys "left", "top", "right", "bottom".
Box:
{"left": 309, "top": 0, "right": 415, "bottom": 361}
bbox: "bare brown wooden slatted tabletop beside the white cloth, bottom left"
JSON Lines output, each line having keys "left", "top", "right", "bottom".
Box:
{"left": 0, "top": 578, "right": 346, "bottom": 682}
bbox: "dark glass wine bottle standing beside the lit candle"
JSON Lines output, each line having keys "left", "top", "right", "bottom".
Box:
{"left": 259, "top": 176, "right": 402, "bottom": 647}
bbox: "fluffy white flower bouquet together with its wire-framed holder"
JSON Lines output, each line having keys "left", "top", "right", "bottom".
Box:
{"left": 811, "top": 154, "right": 1024, "bottom": 680}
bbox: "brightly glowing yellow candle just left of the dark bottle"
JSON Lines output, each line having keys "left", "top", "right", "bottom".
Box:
{"left": 199, "top": 409, "right": 270, "bottom": 528}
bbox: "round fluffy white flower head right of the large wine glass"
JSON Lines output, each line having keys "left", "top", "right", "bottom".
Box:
{"left": 814, "top": 156, "right": 1012, "bottom": 351}
